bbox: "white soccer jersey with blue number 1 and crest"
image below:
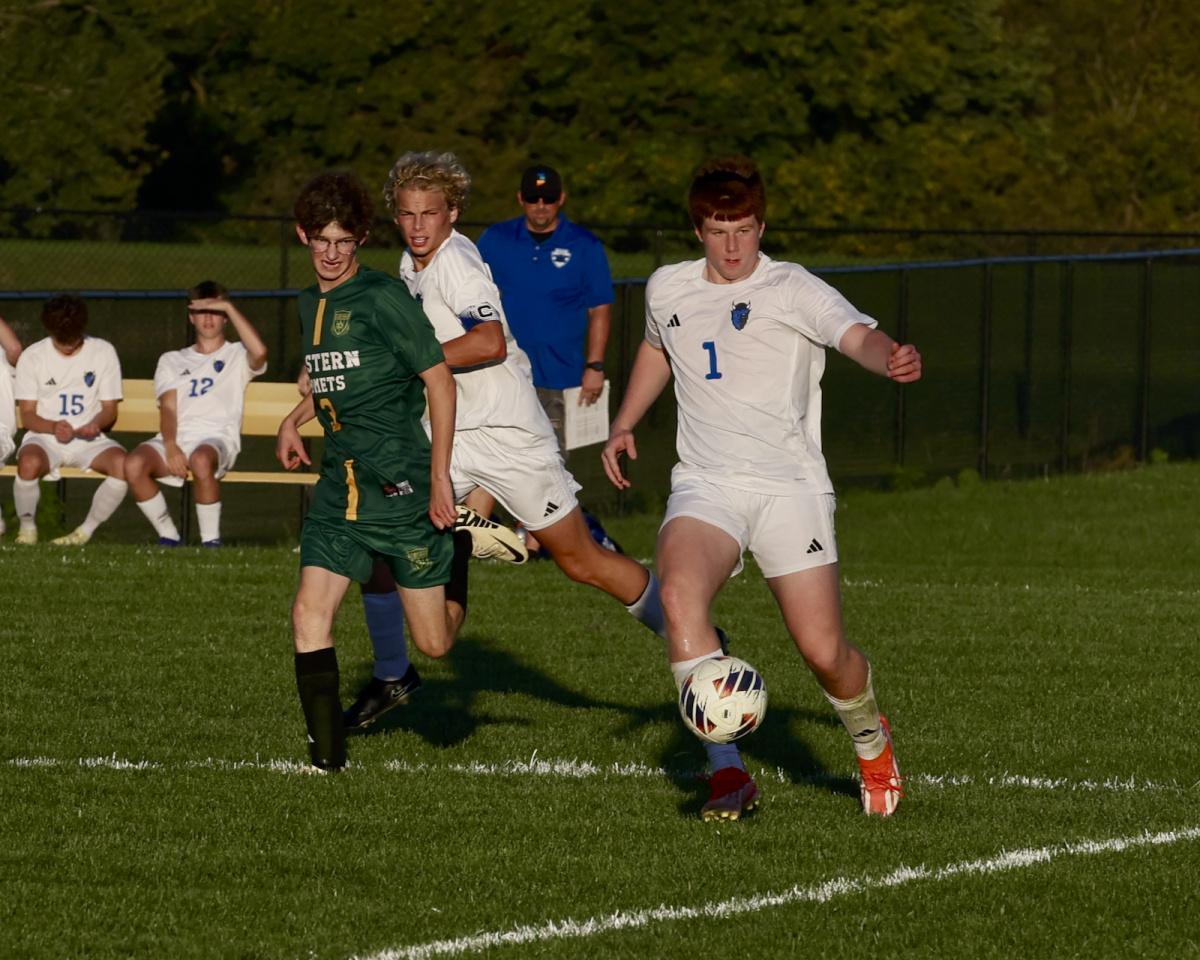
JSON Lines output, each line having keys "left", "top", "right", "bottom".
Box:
{"left": 646, "top": 254, "right": 876, "bottom": 493}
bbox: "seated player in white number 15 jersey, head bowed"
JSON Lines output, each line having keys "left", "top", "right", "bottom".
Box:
{"left": 12, "top": 294, "right": 126, "bottom": 546}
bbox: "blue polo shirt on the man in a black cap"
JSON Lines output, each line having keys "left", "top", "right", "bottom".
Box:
{"left": 478, "top": 214, "right": 613, "bottom": 390}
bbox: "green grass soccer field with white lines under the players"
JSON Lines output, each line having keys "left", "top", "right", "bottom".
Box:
{"left": 0, "top": 464, "right": 1200, "bottom": 960}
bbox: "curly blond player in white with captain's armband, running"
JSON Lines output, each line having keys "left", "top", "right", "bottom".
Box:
{"left": 346, "top": 152, "right": 662, "bottom": 727}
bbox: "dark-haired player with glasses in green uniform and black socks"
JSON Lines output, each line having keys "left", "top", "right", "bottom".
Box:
{"left": 276, "top": 174, "right": 458, "bottom": 770}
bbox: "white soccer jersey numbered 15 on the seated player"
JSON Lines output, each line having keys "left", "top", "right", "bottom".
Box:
{"left": 16, "top": 337, "right": 121, "bottom": 427}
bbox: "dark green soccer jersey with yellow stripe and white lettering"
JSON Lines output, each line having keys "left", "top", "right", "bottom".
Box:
{"left": 299, "top": 266, "right": 444, "bottom": 523}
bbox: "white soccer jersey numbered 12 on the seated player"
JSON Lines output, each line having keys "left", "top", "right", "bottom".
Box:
{"left": 154, "top": 342, "right": 266, "bottom": 454}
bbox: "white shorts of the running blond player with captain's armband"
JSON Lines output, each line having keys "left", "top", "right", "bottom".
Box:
{"left": 450, "top": 427, "right": 582, "bottom": 530}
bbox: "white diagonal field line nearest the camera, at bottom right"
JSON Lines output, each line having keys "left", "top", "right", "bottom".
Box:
{"left": 352, "top": 827, "right": 1200, "bottom": 960}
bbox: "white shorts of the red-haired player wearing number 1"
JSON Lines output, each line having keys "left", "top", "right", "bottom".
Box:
{"left": 662, "top": 475, "right": 838, "bottom": 578}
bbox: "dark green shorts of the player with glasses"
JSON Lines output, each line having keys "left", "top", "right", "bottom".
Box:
{"left": 300, "top": 517, "right": 454, "bottom": 589}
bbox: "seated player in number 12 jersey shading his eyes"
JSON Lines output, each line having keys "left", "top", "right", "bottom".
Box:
{"left": 125, "top": 280, "right": 266, "bottom": 547}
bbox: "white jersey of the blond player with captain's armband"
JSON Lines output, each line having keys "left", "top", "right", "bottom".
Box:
{"left": 400, "top": 230, "right": 554, "bottom": 437}
